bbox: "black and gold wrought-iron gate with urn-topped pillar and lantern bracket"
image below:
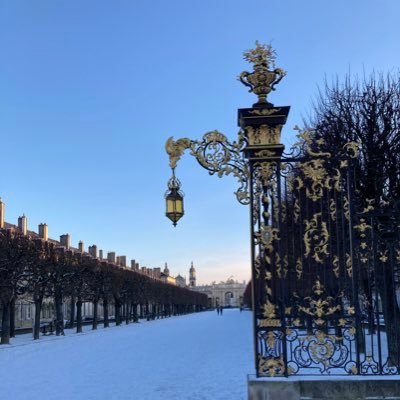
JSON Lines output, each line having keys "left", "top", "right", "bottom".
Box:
{"left": 166, "top": 43, "right": 400, "bottom": 376}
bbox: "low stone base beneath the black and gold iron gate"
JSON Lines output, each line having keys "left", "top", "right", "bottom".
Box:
{"left": 248, "top": 375, "right": 400, "bottom": 400}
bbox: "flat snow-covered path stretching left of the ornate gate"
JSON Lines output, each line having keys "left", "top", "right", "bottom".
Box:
{"left": 0, "top": 309, "right": 254, "bottom": 400}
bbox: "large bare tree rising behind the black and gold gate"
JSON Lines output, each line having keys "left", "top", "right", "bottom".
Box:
{"left": 305, "top": 73, "right": 400, "bottom": 362}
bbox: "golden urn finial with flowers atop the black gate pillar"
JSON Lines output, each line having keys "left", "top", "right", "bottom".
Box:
{"left": 238, "top": 41, "right": 286, "bottom": 107}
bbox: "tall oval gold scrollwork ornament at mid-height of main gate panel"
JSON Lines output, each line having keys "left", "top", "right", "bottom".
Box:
{"left": 303, "top": 213, "right": 329, "bottom": 264}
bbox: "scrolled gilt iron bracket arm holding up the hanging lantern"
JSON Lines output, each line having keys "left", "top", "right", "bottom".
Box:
{"left": 165, "top": 131, "right": 250, "bottom": 204}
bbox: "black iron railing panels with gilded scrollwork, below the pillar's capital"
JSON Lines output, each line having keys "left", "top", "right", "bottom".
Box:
{"left": 250, "top": 131, "right": 400, "bottom": 377}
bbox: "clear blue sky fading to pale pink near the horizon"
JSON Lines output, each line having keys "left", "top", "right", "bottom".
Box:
{"left": 0, "top": 0, "right": 400, "bottom": 283}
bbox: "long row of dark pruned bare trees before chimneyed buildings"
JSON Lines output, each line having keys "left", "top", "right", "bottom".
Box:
{"left": 0, "top": 229, "right": 207, "bottom": 344}
